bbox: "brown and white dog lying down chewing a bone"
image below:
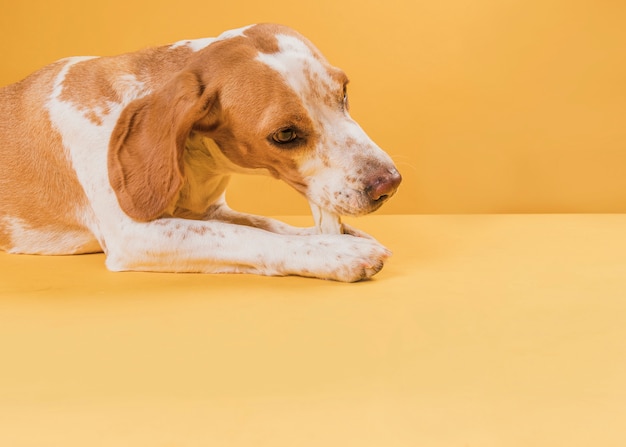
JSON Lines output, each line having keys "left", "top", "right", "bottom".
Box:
{"left": 0, "top": 24, "right": 401, "bottom": 281}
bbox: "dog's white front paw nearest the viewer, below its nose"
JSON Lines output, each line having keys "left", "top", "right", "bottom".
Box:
{"left": 325, "top": 235, "right": 391, "bottom": 282}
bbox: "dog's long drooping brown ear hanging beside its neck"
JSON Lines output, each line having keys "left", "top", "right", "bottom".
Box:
{"left": 108, "top": 71, "right": 217, "bottom": 221}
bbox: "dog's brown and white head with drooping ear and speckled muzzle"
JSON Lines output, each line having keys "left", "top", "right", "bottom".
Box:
{"left": 109, "top": 25, "right": 401, "bottom": 220}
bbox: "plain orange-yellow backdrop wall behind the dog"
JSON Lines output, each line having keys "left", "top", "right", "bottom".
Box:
{"left": 0, "top": 0, "right": 626, "bottom": 214}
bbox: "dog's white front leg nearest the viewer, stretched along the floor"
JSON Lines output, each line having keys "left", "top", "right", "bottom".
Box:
{"left": 105, "top": 218, "right": 391, "bottom": 282}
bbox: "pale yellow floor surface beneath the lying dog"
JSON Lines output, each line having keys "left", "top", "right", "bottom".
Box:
{"left": 0, "top": 215, "right": 626, "bottom": 447}
